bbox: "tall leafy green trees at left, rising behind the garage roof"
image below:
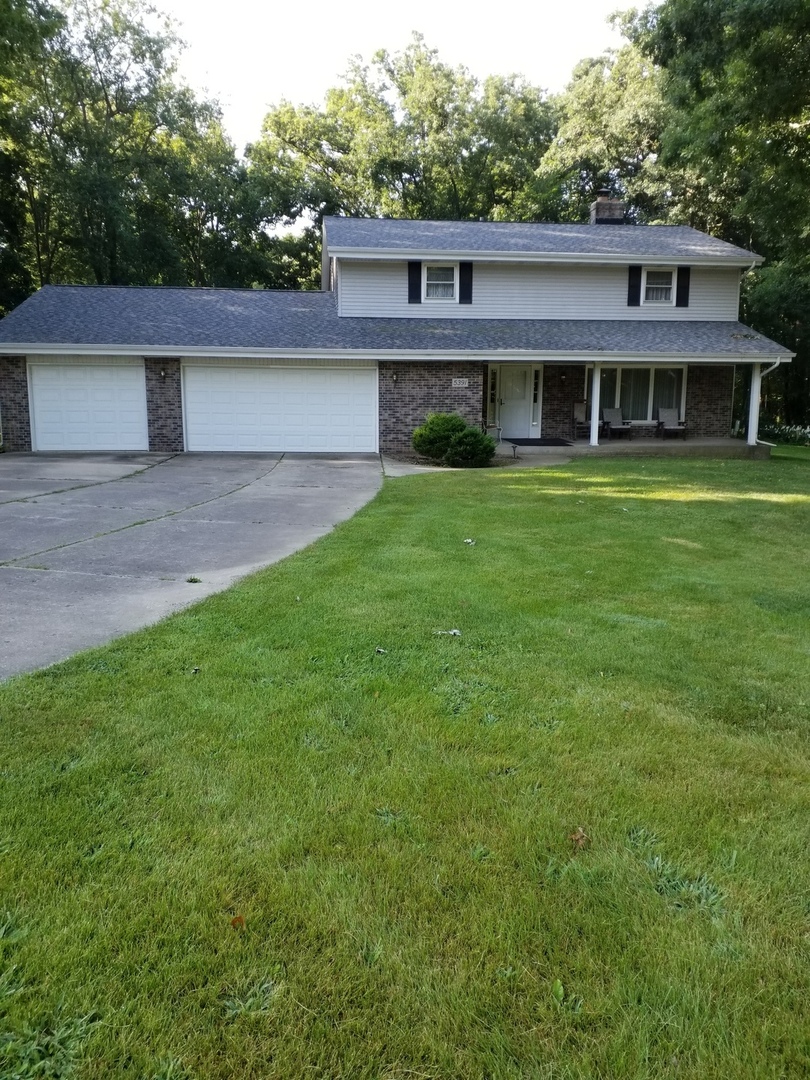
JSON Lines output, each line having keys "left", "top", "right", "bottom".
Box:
{"left": 0, "top": 0, "right": 302, "bottom": 310}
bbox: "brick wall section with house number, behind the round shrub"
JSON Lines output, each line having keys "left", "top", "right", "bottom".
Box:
{"left": 379, "top": 361, "right": 484, "bottom": 451}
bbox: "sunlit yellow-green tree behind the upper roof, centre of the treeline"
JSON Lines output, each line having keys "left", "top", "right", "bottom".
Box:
{"left": 248, "top": 35, "right": 554, "bottom": 220}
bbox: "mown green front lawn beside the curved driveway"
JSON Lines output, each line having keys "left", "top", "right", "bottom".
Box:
{"left": 0, "top": 459, "right": 810, "bottom": 1080}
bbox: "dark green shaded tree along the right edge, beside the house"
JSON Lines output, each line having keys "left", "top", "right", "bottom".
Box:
{"left": 625, "top": 0, "right": 810, "bottom": 423}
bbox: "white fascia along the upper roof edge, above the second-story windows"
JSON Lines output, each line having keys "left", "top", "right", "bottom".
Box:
{"left": 329, "top": 247, "right": 765, "bottom": 270}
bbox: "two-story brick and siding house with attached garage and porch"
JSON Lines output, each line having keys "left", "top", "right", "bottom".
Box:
{"left": 0, "top": 194, "right": 793, "bottom": 453}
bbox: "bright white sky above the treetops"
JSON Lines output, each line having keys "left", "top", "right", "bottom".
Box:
{"left": 153, "top": 0, "right": 632, "bottom": 152}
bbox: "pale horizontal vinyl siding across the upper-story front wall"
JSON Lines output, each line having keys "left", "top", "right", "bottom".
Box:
{"left": 339, "top": 259, "right": 740, "bottom": 321}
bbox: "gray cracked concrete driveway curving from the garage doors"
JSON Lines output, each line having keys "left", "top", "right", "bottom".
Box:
{"left": 0, "top": 454, "right": 382, "bottom": 678}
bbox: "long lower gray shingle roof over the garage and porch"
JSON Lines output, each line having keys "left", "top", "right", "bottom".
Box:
{"left": 0, "top": 285, "right": 792, "bottom": 360}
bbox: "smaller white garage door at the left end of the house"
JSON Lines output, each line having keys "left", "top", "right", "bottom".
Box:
{"left": 28, "top": 362, "right": 149, "bottom": 450}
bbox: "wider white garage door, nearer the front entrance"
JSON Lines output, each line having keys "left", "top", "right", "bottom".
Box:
{"left": 183, "top": 364, "right": 377, "bottom": 453}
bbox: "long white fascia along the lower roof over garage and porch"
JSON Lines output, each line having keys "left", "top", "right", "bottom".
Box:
{"left": 6, "top": 342, "right": 796, "bottom": 364}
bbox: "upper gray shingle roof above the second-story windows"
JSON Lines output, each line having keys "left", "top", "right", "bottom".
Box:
{"left": 324, "top": 217, "right": 759, "bottom": 264}
